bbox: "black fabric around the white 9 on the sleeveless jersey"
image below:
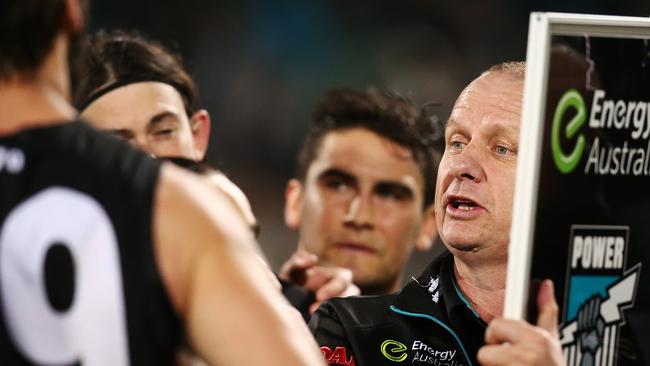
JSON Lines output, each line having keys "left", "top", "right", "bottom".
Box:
{"left": 0, "top": 122, "right": 181, "bottom": 365}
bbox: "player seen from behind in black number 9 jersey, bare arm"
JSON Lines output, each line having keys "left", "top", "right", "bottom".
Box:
{"left": 0, "top": 0, "right": 321, "bottom": 365}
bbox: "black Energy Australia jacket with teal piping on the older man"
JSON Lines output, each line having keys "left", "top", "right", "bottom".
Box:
{"left": 309, "top": 253, "right": 486, "bottom": 366}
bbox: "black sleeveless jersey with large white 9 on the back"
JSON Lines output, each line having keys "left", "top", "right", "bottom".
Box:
{"left": 0, "top": 122, "right": 181, "bottom": 365}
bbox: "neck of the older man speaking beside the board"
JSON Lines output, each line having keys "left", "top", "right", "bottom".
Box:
{"left": 454, "top": 254, "right": 506, "bottom": 322}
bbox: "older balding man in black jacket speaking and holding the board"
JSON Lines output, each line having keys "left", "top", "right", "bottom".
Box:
{"left": 310, "top": 63, "right": 563, "bottom": 366}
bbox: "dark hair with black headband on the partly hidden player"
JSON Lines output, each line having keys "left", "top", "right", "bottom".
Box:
{"left": 73, "top": 30, "right": 198, "bottom": 116}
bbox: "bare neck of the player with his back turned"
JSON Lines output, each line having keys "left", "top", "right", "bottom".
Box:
{"left": 0, "top": 36, "right": 76, "bottom": 135}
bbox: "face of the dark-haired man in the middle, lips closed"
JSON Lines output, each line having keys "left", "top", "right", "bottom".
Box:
{"left": 287, "top": 128, "right": 433, "bottom": 293}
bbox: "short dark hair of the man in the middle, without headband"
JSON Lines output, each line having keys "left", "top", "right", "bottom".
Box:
{"left": 296, "top": 88, "right": 443, "bottom": 207}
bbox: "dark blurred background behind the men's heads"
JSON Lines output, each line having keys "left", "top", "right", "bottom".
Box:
{"left": 90, "top": 0, "right": 650, "bottom": 279}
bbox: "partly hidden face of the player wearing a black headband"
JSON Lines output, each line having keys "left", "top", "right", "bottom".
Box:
{"left": 81, "top": 82, "right": 202, "bottom": 160}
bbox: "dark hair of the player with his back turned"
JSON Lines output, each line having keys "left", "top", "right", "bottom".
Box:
{"left": 0, "top": 0, "right": 65, "bottom": 80}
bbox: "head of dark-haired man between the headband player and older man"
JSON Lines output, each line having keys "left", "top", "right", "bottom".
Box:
{"left": 281, "top": 89, "right": 437, "bottom": 294}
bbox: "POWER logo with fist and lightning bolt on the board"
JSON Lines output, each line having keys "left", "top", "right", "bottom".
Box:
{"left": 560, "top": 225, "right": 641, "bottom": 366}
